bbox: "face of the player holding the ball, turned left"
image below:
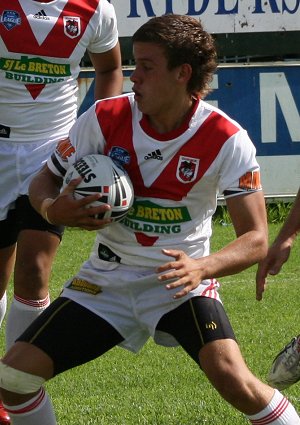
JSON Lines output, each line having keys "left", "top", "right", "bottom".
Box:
{"left": 131, "top": 42, "right": 186, "bottom": 117}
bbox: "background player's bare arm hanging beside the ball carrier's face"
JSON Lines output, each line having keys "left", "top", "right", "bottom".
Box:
{"left": 89, "top": 43, "right": 123, "bottom": 100}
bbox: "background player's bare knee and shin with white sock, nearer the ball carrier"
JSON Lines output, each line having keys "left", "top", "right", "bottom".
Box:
{"left": 6, "top": 230, "right": 60, "bottom": 348}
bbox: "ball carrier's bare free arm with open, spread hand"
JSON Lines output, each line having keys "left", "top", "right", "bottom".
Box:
{"left": 157, "top": 191, "right": 268, "bottom": 298}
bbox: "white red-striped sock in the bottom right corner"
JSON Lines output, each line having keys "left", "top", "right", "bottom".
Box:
{"left": 248, "top": 390, "right": 300, "bottom": 425}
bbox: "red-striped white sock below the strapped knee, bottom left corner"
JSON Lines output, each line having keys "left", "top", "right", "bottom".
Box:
{"left": 4, "top": 388, "right": 57, "bottom": 425}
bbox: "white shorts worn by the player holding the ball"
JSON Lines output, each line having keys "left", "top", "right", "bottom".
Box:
{"left": 61, "top": 261, "right": 220, "bottom": 352}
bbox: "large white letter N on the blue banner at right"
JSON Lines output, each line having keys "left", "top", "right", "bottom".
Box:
{"left": 259, "top": 72, "right": 300, "bottom": 143}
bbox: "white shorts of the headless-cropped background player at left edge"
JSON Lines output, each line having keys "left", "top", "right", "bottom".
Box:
{"left": 0, "top": 139, "right": 57, "bottom": 220}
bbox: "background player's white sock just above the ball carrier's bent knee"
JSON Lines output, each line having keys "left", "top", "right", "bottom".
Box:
{"left": 6, "top": 295, "right": 50, "bottom": 350}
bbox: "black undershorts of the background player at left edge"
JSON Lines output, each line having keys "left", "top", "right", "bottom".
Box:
{"left": 0, "top": 195, "right": 64, "bottom": 249}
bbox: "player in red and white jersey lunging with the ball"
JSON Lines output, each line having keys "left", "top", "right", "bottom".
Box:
{"left": 0, "top": 15, "right": 300, "bottom": 425}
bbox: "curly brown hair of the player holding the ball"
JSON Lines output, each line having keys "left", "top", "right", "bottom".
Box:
{"left": 132, "top": 14, "right": 217, "bottom": 97}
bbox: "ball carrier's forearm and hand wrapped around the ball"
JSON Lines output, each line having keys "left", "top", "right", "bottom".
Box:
{"left": 29, "top": 165, "right": 110, "bottom": 230}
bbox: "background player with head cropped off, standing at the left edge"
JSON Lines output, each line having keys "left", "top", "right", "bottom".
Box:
{"left": 0, "top": 0, "right": 123, "bottom": 424}
